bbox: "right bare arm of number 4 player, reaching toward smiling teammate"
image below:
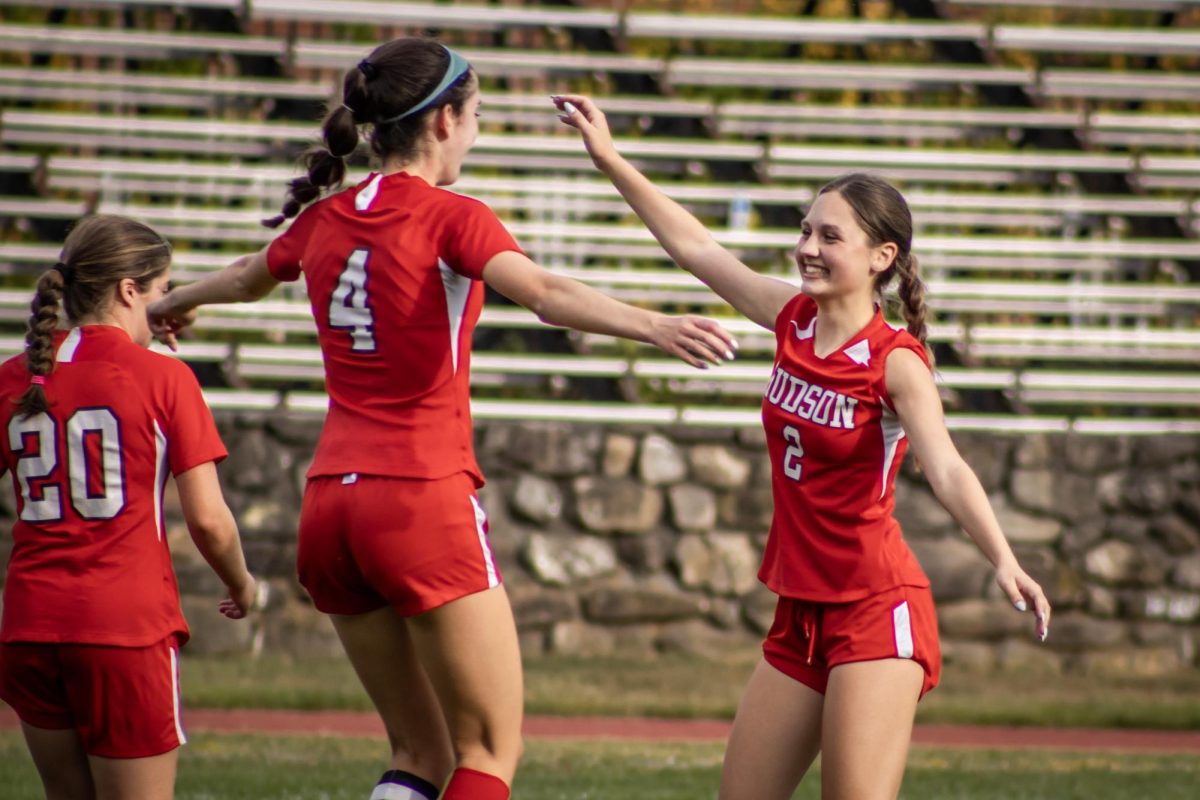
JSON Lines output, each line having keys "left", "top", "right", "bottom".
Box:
{"left": 484, "top": 251, "right": 737, "bottom": 367}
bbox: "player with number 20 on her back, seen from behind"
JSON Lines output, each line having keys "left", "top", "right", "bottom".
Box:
{"left": 0, "top": 216, "right": 256, "bottom": 800}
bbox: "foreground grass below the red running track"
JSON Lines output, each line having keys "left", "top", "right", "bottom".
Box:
{"left": 0, "top": 730, "right": 1200, "bottom": 800}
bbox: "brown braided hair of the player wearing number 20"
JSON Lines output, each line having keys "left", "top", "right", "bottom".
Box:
{"left": 17, "top": 213, "right": 170, "bottom": 417}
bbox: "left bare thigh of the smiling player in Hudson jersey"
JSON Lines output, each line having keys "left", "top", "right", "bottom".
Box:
{"left": 720, "top": 661, "right": 824, "bottom": 800}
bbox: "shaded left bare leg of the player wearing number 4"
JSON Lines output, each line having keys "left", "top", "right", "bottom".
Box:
{"left": 331, "top": 608, "right": 454, "bottom": 786}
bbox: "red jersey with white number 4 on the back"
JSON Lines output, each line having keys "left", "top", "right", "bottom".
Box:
{"left": 266, "top": 173, "right": 521, "bottom": 485}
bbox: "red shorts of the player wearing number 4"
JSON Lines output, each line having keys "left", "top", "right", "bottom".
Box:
{"left": 296, "top": 473, "right": 500, "bottom": 616}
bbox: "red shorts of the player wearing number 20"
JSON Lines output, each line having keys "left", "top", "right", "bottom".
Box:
{"left": 0, "top": 636, "right": 187, "bottom": 758}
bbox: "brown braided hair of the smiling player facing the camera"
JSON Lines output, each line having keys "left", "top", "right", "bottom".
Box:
{"left": 817, "top": 173, "right": 934, "bottom": 361}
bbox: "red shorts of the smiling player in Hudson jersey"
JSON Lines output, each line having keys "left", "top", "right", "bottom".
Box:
{"left": 762, "top": 587, "right": 942, "bottom": 696}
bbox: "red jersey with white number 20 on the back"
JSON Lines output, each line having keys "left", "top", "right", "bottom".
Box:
{"left": 0, "top": 325, "right": 226, "bottom": 646}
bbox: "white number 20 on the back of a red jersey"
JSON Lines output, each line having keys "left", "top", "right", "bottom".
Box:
{"left": 8, "top": 408, "right": 125, "bottom": 522}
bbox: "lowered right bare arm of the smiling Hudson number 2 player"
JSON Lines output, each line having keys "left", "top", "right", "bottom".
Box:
{"left": 887, "top": 349, "right": 1050, "bottom": 640}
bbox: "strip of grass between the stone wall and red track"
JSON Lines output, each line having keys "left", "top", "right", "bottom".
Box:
{"left": 175, "top": 652, "right": 1200, "bottom": 730}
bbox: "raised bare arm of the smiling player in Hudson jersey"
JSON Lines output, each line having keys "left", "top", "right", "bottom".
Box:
{"left": 554, "top": 95, "right": 799, "bottom": 330}
